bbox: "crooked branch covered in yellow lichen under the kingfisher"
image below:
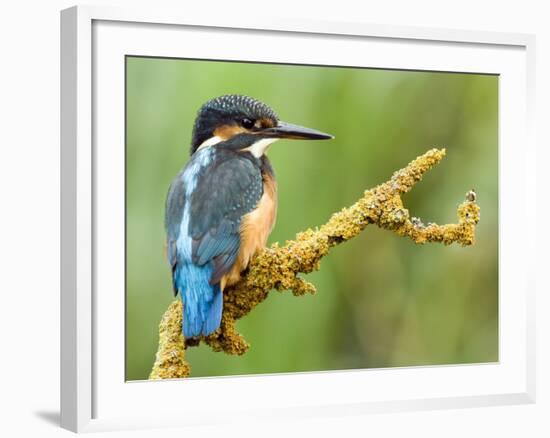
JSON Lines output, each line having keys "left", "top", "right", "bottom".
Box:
{"left": 150, "top": 149, "right": 479, "bottom": 379}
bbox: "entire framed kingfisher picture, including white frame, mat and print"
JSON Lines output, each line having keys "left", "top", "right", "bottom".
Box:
{"left": 61, "top": 6, "right": 535, "bottom": 432}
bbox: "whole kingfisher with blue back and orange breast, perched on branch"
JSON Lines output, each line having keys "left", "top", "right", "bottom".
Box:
{"left": 165, "top": 94, "right": 333, "bottom": 338}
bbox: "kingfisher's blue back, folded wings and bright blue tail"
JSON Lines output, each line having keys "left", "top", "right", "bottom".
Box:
{"left": 165, "top": 149, "right": 263, "bottom": 337}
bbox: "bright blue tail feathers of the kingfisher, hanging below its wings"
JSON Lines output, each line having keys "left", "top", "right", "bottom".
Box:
{"left": 174, "top": 263, "right": 223, "bottom": 338}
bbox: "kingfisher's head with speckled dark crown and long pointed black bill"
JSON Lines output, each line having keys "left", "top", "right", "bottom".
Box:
{"left": 191, "top": 94, "right": 334, "bottom": 157}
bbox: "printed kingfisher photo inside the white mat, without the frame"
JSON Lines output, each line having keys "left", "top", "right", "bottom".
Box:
{"left": 125, "top": 56, "right": 499, "bottom": 380}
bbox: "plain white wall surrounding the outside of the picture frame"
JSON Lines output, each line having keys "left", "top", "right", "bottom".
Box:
{"left": 0, "top": 0, "right": 550, "bottom": 437}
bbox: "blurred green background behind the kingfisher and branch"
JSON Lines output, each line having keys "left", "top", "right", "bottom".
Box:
{"left": 126, "top": 57, "right": 498, "bottom": 380}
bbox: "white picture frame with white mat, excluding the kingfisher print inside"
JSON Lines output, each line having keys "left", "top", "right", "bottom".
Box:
{"left": 61, "top": 6, "right": 535, "bottom": 432}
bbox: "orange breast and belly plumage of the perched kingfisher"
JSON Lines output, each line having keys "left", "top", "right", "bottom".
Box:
{"left": 220, "top": 174, "right": 277, "bottom": 290}
